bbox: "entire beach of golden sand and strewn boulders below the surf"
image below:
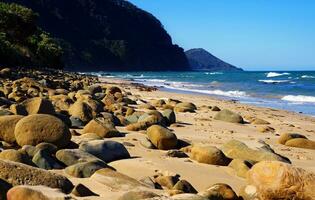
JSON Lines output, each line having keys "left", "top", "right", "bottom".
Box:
{"left": 0, "top": 70, "right": 315, "bottom": 200}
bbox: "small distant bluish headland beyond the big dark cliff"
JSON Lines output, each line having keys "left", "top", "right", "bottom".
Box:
{"left": 185, "top": 49, "right": 243, "bottom": 71}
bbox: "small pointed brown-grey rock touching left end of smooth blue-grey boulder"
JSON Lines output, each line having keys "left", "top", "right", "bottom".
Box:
{"left": 56, "top": 149, "right": 100, "bottom": 166}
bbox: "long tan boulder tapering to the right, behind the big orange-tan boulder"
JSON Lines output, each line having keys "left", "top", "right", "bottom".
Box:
{"left": 221, "top": 140, "right": 289, "bottom": 162}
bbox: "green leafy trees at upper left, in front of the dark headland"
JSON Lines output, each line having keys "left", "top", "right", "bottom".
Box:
{"left": 0, "top": 2, "right": 62, "bottom": 68}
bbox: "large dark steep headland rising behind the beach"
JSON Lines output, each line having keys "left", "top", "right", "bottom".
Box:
{"left": 4, "top": 0, "right": 189, "bottom": 71}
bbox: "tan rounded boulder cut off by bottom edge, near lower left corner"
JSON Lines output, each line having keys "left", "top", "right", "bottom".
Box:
{"left": 7, "top": 185, "right": 70, "bottom": 200}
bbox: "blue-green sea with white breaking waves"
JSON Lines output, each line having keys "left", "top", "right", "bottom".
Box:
{"left": 89, "top": 71, "right": 315, "bottom": 116}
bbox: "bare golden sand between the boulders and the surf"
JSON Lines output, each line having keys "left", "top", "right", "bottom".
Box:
{"left": 75, "top": 78, "right": 315, "bottom": 198}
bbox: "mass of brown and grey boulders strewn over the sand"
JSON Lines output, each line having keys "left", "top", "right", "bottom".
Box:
{"left": 0, "top": 70, "right": 315, "bottom": 200}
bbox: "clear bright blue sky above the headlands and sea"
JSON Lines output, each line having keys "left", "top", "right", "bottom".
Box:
{"left": 130, "top": 0, "right": 315, "bottom": 70}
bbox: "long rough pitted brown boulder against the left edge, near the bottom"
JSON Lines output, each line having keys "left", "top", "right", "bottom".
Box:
{"left": 0, "top": 159, "right": 73, "bottom": 193}
